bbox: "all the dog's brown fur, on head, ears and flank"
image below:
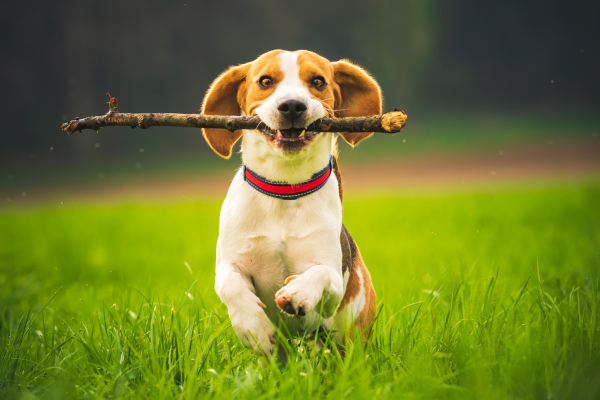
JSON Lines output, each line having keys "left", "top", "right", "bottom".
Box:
{"left": 201, "top": 50, "right": 382, "bottom": 330}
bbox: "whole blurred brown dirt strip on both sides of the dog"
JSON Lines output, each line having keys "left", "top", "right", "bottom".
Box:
{"left": 0, "top": 138, "right": 600, "bottom": 206}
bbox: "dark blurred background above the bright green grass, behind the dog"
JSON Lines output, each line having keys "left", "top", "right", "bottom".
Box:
{"left": 0, "top": 0, "right": 600, "bottom": 205}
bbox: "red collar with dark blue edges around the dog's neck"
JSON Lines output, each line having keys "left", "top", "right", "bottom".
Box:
{"left": 242, "top": 156, "right": 333, "bottom": 200}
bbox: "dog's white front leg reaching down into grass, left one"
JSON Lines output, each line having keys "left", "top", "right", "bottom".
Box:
{"left": 215, "top": 263, "right": 275, "bottom": 357}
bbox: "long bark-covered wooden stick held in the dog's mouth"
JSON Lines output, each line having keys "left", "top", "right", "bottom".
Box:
{"left": 62, "top": 93, "right": 407, "bottom": 135}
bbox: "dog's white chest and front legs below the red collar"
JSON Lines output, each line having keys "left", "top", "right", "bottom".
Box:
{"left": 215, "top": 160, "right": 345, "bottom": 353}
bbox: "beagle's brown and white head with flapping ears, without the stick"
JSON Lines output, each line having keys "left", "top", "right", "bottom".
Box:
{"left": 201, "top": 50, "right": 382, "bottom": 158}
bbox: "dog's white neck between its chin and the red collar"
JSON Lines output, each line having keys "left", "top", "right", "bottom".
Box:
{"left": 242, "top": 131, "right": 335, "bottom": 185}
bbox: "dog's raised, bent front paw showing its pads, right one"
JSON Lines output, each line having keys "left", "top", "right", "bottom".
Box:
{"left": 275, "top": 265, "right": 344, "bottom": 318}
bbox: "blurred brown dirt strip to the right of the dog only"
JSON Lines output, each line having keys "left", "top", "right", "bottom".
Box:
{"left": 342, "top": 138, "right": 600, "bottom": 190}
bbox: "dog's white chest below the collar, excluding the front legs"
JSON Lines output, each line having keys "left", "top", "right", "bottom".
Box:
{"left": 217, "top": 173, "right": 342, "bottom": 329}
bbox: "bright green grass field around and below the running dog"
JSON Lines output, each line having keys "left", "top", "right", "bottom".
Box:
{"left": 0, "top": 181, "right": 600, "bottom": 399}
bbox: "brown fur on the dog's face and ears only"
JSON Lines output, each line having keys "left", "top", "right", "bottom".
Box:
{"left": 201, "top": 50, "right": 382, "bottom": 159}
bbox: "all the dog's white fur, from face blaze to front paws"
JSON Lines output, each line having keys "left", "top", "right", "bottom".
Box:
{"left": 215, "top": 53, "right": 344, "bottom": 354}
